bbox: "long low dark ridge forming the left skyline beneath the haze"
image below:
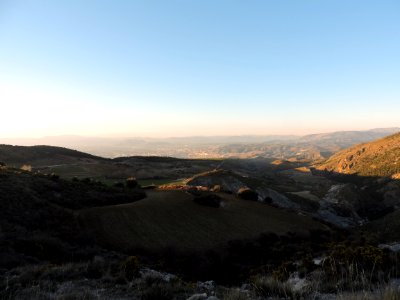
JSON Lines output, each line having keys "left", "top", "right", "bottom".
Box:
{"left": 0, "top": 145, "right": 221, "bottom": 185}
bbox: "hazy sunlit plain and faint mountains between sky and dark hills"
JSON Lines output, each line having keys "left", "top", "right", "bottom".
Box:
{"left": 0, "top": 127, "right": 400, "bottom": 160}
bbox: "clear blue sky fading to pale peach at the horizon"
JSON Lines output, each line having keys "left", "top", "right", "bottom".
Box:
{"left": 0, "top": 0, "right": 400, "bottom": 138}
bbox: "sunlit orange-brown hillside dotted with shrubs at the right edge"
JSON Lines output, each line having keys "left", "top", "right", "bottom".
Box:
{"left": 316, "top": 133, "right": 400, "bottom": 178}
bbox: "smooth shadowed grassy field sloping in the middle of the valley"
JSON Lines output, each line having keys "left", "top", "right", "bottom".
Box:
{"left": 79, "top": 191, "right": 327, "bottom": 251}
